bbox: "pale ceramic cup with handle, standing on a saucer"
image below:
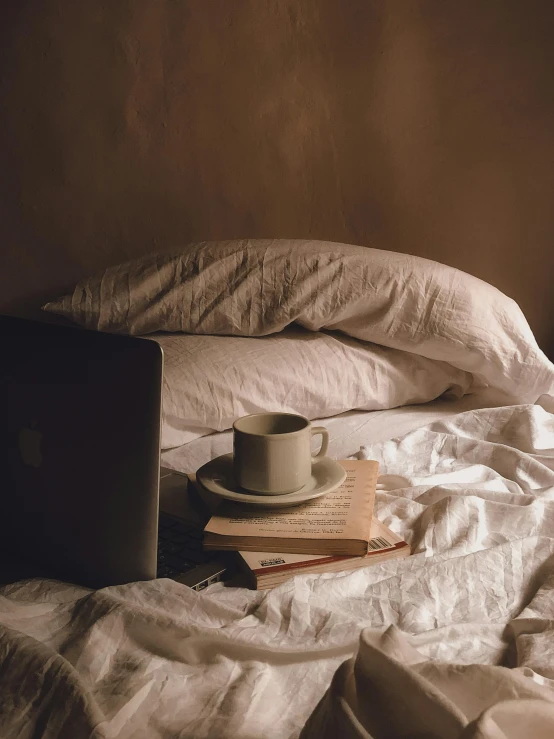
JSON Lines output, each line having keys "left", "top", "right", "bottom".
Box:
{"left": 233, "top": 413, "right": 329, "bottom": 495}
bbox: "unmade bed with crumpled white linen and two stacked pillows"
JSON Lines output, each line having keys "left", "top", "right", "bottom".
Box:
{"left": 0, "top": 240, "right": 554, "bottom": 739}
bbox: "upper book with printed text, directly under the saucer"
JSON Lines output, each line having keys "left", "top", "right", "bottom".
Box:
{"left": 203, "top": 460, "right": 379, "bottom": 556}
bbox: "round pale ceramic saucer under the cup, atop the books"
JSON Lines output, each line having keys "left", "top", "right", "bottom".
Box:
{"left": 196, "top": 454, "right": 346, "bottom": 508}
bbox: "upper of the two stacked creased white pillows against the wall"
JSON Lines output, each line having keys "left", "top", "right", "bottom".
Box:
{"left": 44, "top": 239, "right": 554, "bottom": 402}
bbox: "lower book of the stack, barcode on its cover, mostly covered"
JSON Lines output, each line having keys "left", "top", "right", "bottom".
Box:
{"left": 238, "top": 518, "right": 410, "bottom": 590}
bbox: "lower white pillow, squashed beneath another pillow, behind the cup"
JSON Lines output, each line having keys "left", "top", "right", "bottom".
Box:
{"left": 148, "top": 328, "right": 471, "bottom": 449}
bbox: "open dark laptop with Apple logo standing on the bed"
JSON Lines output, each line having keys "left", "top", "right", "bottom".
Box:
{"left": 0, "top": 316, "right": 227, "bottom": 590}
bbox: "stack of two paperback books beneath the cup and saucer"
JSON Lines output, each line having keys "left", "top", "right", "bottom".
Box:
{"left": 189, "top": 460, "right": 410, "bottom": 589}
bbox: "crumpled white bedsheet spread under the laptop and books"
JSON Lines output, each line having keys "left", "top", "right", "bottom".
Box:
{"left": 0, "top": 397, "right": 554, "bottom": 739}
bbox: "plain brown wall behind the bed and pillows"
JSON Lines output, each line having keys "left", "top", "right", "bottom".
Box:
{"left": 0, "top": 0, "right": 554, "bottom": 346}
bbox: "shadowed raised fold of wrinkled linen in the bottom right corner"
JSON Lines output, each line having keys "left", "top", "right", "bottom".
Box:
{"left": 301, "top": 626, "right": 554, "bottom": 739}
